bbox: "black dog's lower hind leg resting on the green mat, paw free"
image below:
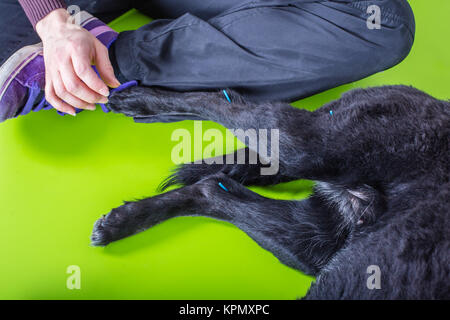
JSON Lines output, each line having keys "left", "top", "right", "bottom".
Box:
{"left": 92, "top": 175, "right": 346, "bottom": 274}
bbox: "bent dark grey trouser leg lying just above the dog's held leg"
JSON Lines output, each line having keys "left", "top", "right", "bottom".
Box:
{"left": 111, "top": 0, "right": 415, "bottom": 101}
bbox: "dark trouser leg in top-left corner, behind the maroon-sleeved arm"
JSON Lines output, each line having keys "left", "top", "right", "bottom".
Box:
{"left": 0, "top": 0, "right": 131, "bottom": 65}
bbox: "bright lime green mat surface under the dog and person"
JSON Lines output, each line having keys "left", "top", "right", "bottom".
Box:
{"left": 0, "top": 0, "right": 450, "bottom": 299}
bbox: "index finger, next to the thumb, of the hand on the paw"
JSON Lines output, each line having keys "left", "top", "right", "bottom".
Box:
{"left": 72, "top": 52, "right": 109, "bottom": 97}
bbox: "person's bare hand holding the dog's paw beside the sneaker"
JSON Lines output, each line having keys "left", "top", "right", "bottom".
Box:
{"left": 36, "top": 9, "right": 120, "bottom": 115}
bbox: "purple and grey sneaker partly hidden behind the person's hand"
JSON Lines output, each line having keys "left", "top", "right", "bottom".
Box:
{"left": 0, "top": 11, "right": 136, "bottom": 122}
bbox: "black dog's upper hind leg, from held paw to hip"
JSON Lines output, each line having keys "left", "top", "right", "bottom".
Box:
{"left": 109, "top": 86, "right": 448, "bottom": 185}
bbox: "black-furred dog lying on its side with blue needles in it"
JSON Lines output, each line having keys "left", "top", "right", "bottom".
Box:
{"left": 92, "top": 86, "right": 450, "bottom": 299}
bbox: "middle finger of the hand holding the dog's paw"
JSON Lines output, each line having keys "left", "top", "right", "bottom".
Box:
{"left": 59, "top": 62, "right": 108, "bottom": 105}
